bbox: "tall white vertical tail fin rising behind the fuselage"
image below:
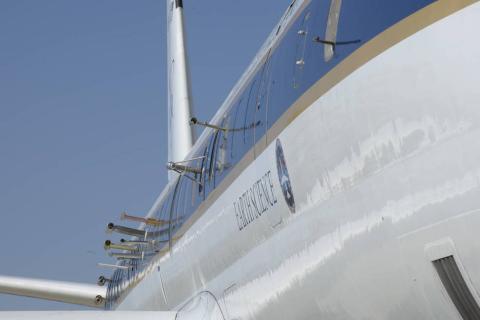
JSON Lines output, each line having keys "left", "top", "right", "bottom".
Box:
{"left": 167, "top": 0, "right": 194, "bottom": 180}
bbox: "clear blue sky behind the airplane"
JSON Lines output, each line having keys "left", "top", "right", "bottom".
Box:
{"left": 0, "top": 0, "right": 290, "bottom": 310}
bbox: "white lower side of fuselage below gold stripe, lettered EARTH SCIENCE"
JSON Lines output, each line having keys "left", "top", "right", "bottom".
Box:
{"left": 118, "top": 3, "right": 480, "bottom": 320}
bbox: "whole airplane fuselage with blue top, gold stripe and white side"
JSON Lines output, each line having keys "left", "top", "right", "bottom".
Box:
{"left": 107, "top": 0, "right": 480, "bottom": 320}
